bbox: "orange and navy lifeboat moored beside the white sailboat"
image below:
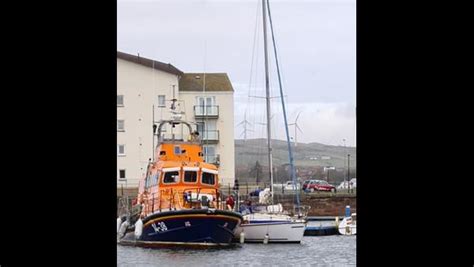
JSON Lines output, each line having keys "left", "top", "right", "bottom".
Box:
{"left": 117, "top": 99, "right": 243, "bottom": 247}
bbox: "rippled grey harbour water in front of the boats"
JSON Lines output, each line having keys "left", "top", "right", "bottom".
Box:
{"left": 117, "top": 235, "right": 356, "bottom": 267}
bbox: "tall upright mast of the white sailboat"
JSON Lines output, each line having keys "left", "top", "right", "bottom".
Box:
{"left": 262, "top": 0, "right": 273, "bottom": 204}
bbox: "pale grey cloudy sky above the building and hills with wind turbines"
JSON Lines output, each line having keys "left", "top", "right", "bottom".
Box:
{"left": 117, "top": 0, "right": 356, "bottom": 146}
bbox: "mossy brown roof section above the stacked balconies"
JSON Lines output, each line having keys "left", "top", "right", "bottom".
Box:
{"left": 179, "top": 73, "right": 234, "bottom": 92}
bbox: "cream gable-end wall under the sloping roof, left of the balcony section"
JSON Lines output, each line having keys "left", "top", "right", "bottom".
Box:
{"left": 117, "top": 58, "right": 178, "bottom": 187}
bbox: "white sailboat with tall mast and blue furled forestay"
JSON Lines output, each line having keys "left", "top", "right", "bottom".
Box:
{"left": 235, "top": 0, "right": 307, "bottom": 243}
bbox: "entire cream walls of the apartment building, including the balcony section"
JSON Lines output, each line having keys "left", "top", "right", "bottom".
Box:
{"left": 117, "top": 58, "right": 235, "bottom": 191}
